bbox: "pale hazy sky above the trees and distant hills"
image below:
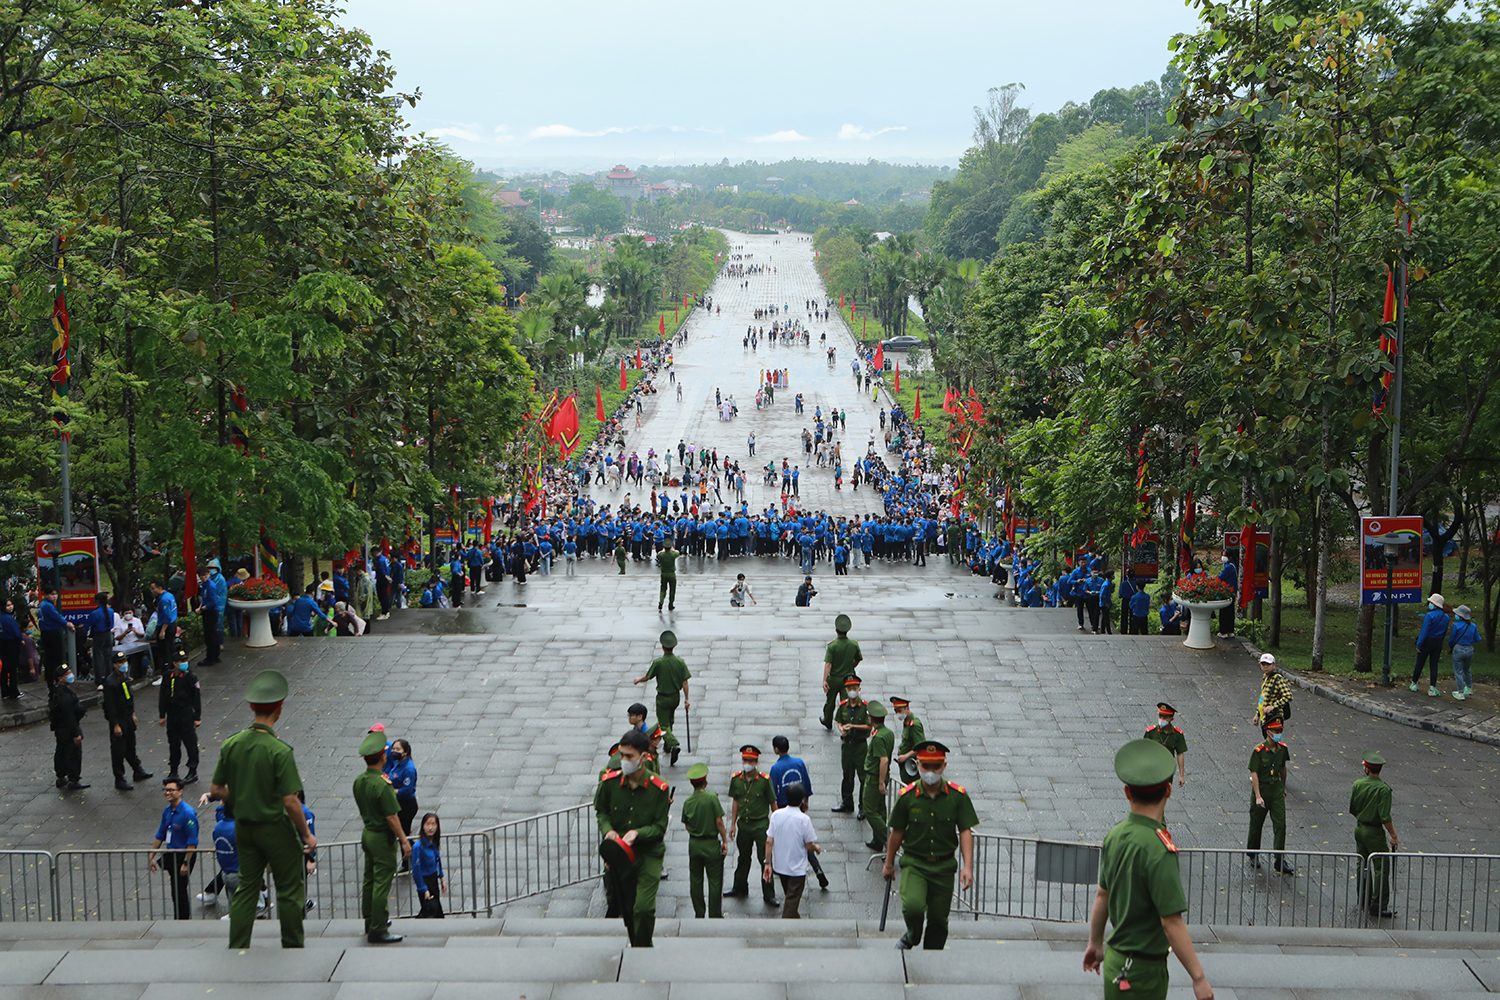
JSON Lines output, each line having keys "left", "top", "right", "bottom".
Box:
{"left": 342, "top": 0, "right": 1197, "bottom": 171}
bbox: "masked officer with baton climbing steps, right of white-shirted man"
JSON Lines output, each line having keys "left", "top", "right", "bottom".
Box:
{"left": 881, "top": 739, "right": 980, "bottom": 949}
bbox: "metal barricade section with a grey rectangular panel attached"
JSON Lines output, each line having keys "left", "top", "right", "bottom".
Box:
{"left": 954, "top": 834, "right": 1100, "bottom": 921}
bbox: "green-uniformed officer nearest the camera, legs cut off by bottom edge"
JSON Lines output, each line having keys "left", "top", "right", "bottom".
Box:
{"left": 1083, "top": 739, "right": 1214, "bottom": 1000}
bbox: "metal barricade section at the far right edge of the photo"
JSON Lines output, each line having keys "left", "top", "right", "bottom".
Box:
{"left": 1370, "top": 853, "right": 1500, "bottom": 933}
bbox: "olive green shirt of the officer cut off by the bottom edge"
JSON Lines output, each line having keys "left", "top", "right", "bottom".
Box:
{"left": 1100, "top": 813, "right": 1188, "bottom": 958}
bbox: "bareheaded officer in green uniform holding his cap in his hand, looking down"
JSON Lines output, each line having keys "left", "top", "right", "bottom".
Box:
{"left": 594, "top": 729, "right": 672, "bottom": 948}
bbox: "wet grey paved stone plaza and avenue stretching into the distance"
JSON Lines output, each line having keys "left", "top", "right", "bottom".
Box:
{"left": 0, "top": 230, "right": 1500, "bottom": 919}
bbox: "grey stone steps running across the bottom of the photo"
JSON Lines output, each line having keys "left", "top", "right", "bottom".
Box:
{"left": 0, "top": 909, "right": 1500, "bottom": 1000}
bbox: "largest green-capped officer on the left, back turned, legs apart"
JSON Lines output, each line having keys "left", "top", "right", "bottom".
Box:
{"left": 207, "top": 670, "right": 318, "bottom": 949}
